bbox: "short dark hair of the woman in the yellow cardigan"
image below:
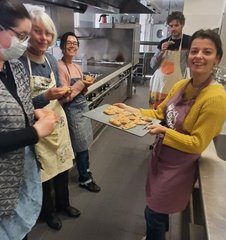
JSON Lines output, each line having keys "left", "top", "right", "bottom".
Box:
{"left": 189, "top": 29, "right": 223, "bottom": 59}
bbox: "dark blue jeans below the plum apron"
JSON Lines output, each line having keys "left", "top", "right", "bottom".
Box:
{"left": 144, "top": 206, "right": 169, "bottom": 240}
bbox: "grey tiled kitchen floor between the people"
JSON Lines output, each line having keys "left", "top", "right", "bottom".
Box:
{"left": 29, "top": 83, "right": 180, "bottom": 240}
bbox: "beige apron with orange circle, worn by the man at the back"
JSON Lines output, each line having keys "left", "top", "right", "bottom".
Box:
{"left": 149, "top": 37, "right": 187, "bottom": 108}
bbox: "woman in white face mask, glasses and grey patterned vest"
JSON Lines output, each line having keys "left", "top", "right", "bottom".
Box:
{"left": 0, "top": 0, "right": 58, "bottom": 240}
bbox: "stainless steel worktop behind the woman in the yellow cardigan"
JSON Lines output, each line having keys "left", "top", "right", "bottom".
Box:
{"left": 199, "top": 124, "right": 226, "bottom": 240}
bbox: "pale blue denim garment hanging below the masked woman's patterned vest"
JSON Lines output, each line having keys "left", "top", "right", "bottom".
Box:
{"left": 0, "top": 147, "right": 42, "bottom": 240}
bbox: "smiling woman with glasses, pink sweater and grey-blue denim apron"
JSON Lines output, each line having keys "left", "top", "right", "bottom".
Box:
{"left": 58, "top": 32, "right": 100, "bottom": 192}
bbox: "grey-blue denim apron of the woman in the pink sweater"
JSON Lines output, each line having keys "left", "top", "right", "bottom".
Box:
{"left": 64, "top": 65, "right": 93, "bottom": 153}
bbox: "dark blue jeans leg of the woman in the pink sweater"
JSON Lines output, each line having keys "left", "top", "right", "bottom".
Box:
{"left": 75, "top": 150, "right": 91, "bottom": 183}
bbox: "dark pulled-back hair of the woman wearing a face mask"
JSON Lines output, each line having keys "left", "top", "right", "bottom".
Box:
{"left": 0, "top": 0, "right": 31, "bottom": 29}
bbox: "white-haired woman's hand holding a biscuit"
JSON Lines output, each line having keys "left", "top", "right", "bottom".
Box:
{"left": 44, "top": 86, "right": 72, "bottom": 101}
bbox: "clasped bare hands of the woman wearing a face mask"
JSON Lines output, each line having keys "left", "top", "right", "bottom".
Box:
{"left": 33, "top": 109, "right": 59, "bottom": 138}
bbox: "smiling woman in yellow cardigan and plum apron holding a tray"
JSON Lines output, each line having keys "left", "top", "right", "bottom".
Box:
{"left": 116, "top": 30, "right": 226, "bottom": 240}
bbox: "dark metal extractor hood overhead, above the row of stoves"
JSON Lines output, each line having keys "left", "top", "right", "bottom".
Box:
{"left": 30, "top": 0, "right": 156, "bottom": 14}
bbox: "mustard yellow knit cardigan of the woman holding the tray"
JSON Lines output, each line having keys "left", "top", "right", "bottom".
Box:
{"left": 140, "top": 80, "right": 226, "bottom": 154}
